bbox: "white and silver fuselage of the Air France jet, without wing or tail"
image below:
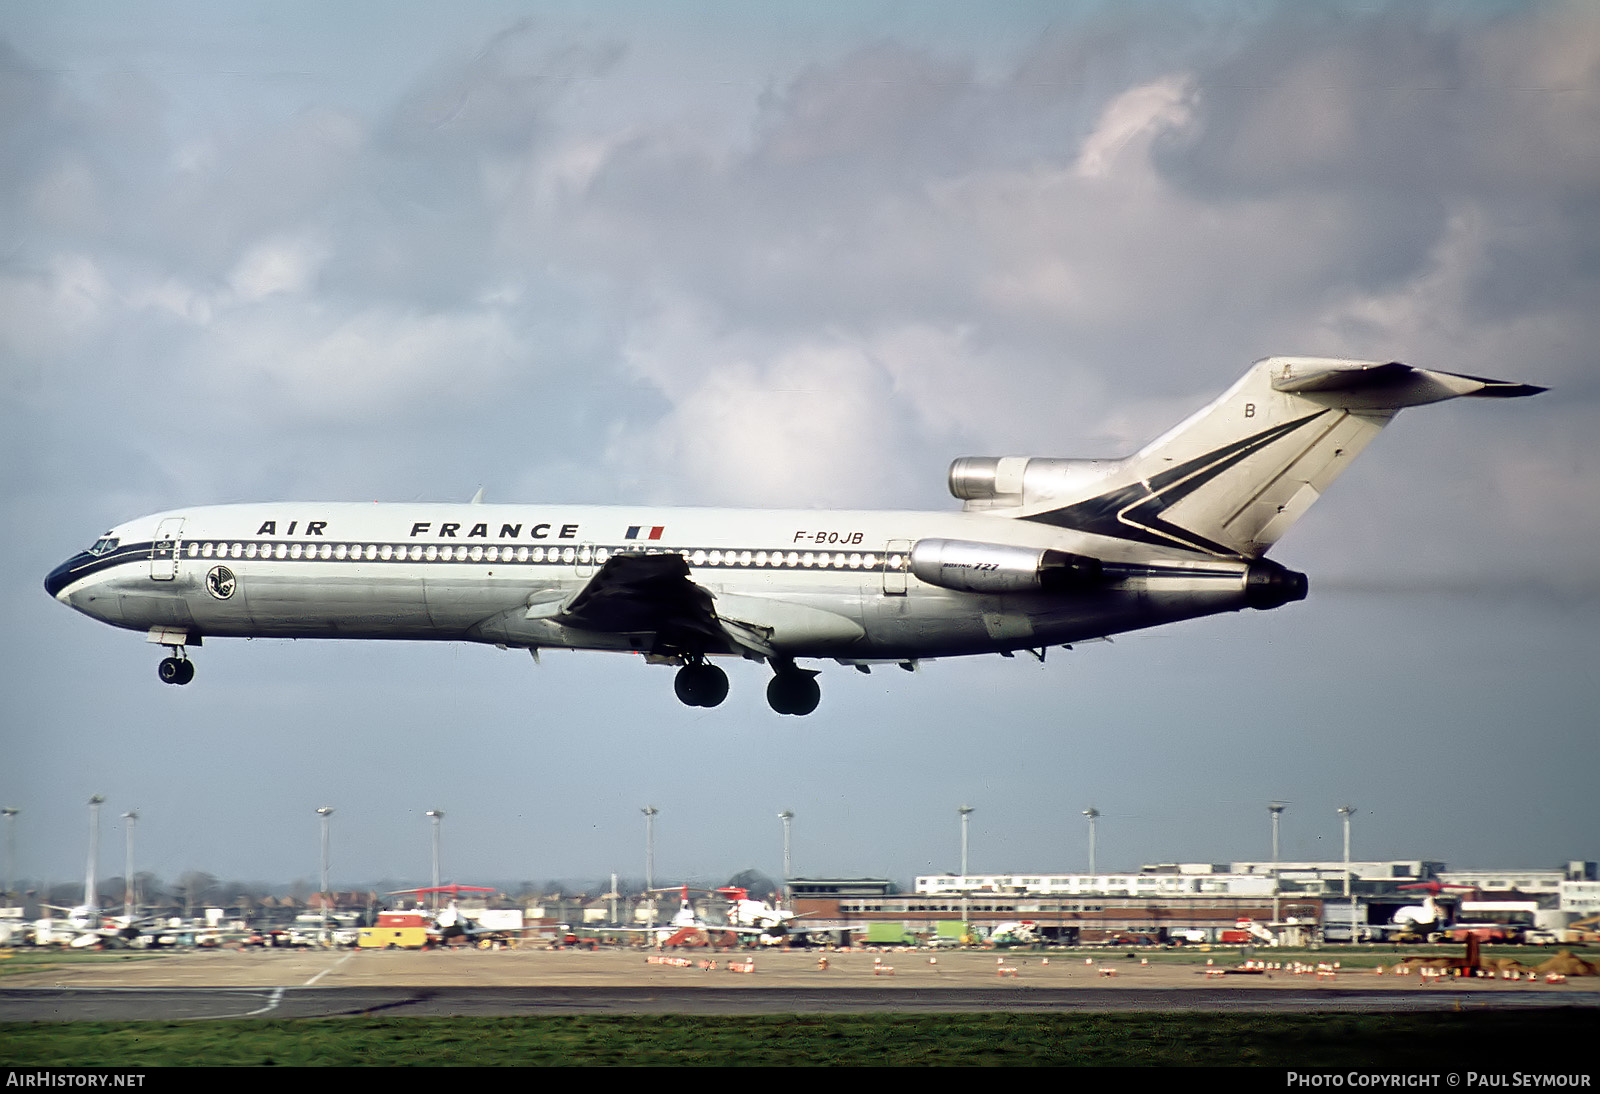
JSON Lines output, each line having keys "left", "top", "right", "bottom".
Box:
{"left": 45, "top": 502, "right": 1270, "bottom": 662}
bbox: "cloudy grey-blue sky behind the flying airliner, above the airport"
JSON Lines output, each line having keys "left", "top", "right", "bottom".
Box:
{"left": 0, "top": 0, "right": 1600, "bottom": 884}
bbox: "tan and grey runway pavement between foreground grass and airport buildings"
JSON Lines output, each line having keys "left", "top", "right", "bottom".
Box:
{"left": 0, "top": 950, "right": 1600, "bottom": 1022}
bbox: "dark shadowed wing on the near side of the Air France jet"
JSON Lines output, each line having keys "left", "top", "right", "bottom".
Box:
{"left": 528, "top": 553, "right": 746, "bottom": 653}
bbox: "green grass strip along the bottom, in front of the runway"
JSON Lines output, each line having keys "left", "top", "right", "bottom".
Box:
{"left": 0, "top": 1008, "right": 1594, "bottom": 1070}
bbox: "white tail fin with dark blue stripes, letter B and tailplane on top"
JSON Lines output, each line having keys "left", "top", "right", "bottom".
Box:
{"left": 1016, "top": 357, "right": 1544, "bottom": 558}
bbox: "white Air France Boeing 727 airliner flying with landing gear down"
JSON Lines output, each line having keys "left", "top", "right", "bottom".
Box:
{"left": 45, "top": 357, "right": 1544, "bottom": 715}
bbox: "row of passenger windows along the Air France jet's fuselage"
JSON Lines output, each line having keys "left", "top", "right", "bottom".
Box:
{"left": 184, "top": 541, "right": 902, "bottom": 569}
